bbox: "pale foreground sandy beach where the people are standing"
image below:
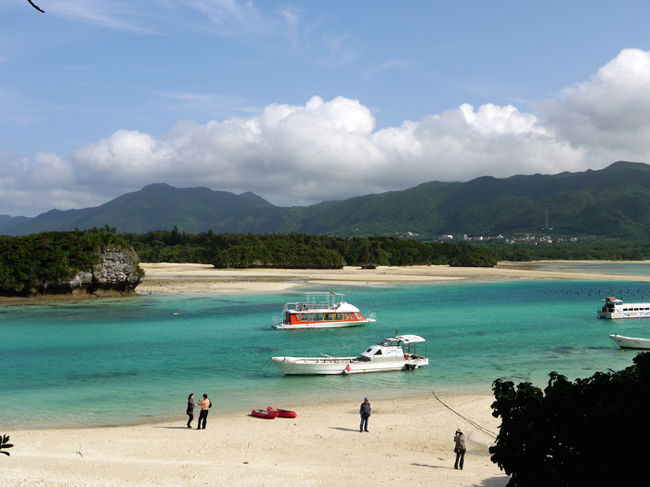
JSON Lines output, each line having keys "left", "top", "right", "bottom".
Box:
{"left": 0, "top": 395, "right": 507, "bottom": 487}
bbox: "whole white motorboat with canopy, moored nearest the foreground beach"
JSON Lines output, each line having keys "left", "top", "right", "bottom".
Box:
{"left": 271, "top": 335, "right": 429, "bottom": 375}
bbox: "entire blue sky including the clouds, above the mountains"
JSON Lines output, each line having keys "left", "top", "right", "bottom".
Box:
{"left": 0, "top": 0, "right": 650, "bottom": 216}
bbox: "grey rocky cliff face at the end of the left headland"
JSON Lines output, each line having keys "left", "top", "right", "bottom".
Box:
{"left": 38, "top": 247, "right": 143, "bottom": 294}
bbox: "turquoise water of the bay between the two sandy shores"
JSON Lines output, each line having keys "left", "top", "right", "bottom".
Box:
{"left": 0, "top": 281, "right": 650, "bottom": 430}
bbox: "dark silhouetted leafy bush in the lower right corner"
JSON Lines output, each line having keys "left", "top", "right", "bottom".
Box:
{"left": 490, "top": 353, "right": 650, "bottom": 487}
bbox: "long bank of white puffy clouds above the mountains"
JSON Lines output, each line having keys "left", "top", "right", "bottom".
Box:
{"left": 0, "top": 49, "right": 650, "bottom": 214}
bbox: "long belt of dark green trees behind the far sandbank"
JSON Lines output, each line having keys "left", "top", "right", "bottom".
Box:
{"left": 124, "top": 229, "right": 496, "bottom": 269}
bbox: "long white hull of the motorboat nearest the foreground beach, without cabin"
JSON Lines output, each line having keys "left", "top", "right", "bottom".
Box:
{"left": 271, "top": 357, "right": 429, "bottom": 375}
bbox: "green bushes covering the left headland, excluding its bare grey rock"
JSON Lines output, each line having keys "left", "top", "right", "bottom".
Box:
{"left": 0, "top": 230, "right": 130, "bottom": 295}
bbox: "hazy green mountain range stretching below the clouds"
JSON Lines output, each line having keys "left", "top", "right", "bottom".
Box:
{"left": 0, "top": 161, "right": 650, "bottom": 238}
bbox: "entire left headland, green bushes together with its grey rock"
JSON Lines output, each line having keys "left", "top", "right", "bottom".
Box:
{"left": 0, "top": 229, "right": 143, "bottom": 296}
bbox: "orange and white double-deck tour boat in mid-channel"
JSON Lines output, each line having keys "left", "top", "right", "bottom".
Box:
{"left": 273, "top": 292, "right": 375, "bottom": 330}
